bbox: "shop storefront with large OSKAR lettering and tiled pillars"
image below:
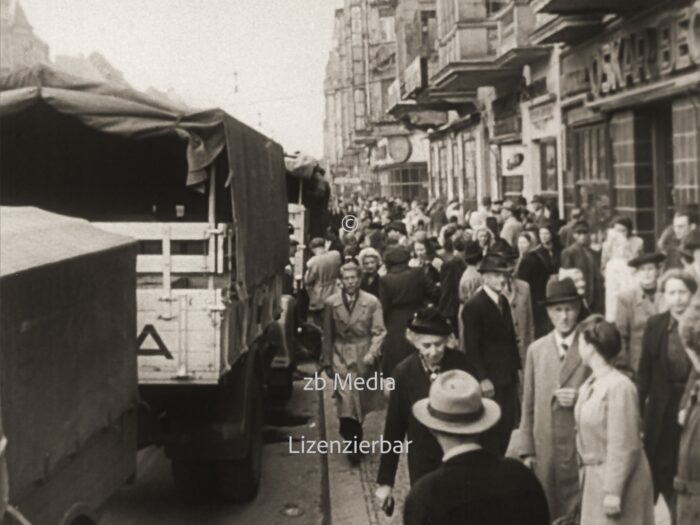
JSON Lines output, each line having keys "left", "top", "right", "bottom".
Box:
{"left": 561, "top": 2, "right": 700, "bottom": 248}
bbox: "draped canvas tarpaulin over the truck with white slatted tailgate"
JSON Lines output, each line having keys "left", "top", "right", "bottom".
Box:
{"left": 0, "top": 66, "right": 288, "bottom": 297}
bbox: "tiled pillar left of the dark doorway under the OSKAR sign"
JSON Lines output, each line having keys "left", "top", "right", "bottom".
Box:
{"left": 610, "top": 110, "right": 654, "bottom": 248}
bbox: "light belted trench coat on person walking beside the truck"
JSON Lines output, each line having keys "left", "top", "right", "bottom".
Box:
{"left": 321, "top": 290, "right": 386, "bottom": 422}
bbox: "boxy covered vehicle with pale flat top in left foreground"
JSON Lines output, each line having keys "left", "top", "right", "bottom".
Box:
{"left": 0, "top": 207, "right": 138, "bottom": 525}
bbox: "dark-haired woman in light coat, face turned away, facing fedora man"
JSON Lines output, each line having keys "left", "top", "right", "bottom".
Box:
{"left": 574, "top": 315, "right": 654, "bottom": 525}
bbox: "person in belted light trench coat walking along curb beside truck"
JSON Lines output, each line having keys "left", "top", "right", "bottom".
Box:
{"left": 321, "top": 262, "right": 386, "bottom": 463}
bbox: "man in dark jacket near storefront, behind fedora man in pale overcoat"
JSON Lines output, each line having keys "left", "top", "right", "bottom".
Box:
{"left": 561, "top": 221, "right": 605, "bottom": 314}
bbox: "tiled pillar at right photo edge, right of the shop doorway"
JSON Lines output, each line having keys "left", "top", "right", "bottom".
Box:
{"left": 672, "top": 95, "right": 700, "bottom": 205}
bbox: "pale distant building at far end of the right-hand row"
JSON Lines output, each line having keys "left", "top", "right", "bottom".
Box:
{"left": 324, "top": 0, "right": 428, "bottom": 199}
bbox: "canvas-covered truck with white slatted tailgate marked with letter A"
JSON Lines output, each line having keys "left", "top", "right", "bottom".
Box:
{"left": 0, "top": 66, "right": 291, "bottom": 501}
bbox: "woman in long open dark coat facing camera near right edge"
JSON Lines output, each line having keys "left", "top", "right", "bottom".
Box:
{"left": 637, "top": 269, "right": 698, "bottom": 523}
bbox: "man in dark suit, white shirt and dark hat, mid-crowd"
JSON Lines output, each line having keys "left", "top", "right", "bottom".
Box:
{"left": 462, "top": 254, "right": 521, "bottom": 454}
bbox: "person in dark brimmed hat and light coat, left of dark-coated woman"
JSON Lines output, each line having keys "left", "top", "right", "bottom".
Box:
{"left": 615, "top": 252, "right": 666, "bottom": 374}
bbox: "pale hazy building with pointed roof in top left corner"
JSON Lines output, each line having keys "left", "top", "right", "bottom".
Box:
{"left": 0, "top": 0, "right": 49, "bottom": 73}
